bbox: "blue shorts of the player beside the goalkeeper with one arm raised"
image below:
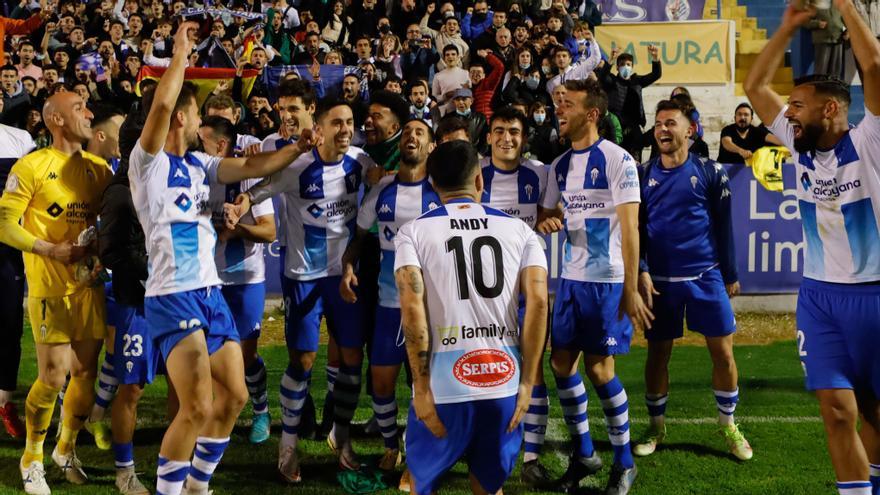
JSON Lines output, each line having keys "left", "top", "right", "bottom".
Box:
{"left": 144, "top": 287, "right": 239, "bottom": 361}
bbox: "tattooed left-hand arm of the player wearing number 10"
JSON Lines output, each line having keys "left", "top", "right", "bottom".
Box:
{"left": 395, "top": 265, "right": 446, "bottom": 438}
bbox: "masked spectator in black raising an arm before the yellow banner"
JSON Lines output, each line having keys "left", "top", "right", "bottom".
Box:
{"left": 596, "top": 45, "right": 662, "bottom": 161}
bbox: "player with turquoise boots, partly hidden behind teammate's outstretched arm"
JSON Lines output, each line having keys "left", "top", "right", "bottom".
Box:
{"left": 199, "top": 117, "right": 275, "bottom": 443}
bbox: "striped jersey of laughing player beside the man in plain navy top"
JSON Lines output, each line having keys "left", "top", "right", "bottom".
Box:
{"left": 542, "top": 139, "right": 640, "bottom": 282}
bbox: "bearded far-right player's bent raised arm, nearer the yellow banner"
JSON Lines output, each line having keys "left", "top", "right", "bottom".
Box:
{"left": 743, "top": 5, "right": 816, "bottom": 124}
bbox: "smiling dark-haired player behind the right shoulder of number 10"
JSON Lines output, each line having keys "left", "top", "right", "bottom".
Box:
{"left": 480, "top": 106, "right": 550, "bottom": 486}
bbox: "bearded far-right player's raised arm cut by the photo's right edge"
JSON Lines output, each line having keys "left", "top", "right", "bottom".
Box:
{"left": 834, "top": 0, "right": 880, "bottom": 115}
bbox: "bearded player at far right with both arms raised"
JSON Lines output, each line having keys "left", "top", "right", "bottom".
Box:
{"left": 743, "top": 0, "right": 880, "bottom": 495}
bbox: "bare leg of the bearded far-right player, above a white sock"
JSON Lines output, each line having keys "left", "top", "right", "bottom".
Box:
{"left": 816, "top": 389, "right": 868, "bottom": 482}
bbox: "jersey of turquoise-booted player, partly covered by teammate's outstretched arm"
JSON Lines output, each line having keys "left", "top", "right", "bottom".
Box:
{"left": 209, "top": 179, "right": 275, "bottom": 285}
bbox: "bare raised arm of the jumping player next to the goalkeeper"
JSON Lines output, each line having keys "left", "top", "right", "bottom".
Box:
{"left": 140, "top": 21, "right": 199, "bottom": 155}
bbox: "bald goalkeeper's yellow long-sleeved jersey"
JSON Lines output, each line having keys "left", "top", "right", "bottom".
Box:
{"left": 0, "top": 147, "right": 113, "bottom": 297}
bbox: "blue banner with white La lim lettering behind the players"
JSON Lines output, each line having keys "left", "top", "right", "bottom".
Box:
{"left": 265, "top": 165, "right": 804, "bottom": 294}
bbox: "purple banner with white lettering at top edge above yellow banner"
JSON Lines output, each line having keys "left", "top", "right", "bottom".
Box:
{"left": 596, "top": 0, "right": 706, "bottom": 22}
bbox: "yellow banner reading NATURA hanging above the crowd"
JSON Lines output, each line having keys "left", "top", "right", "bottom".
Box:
{"left": 596, "top": 21, "right": 733, "bottom": 84}
